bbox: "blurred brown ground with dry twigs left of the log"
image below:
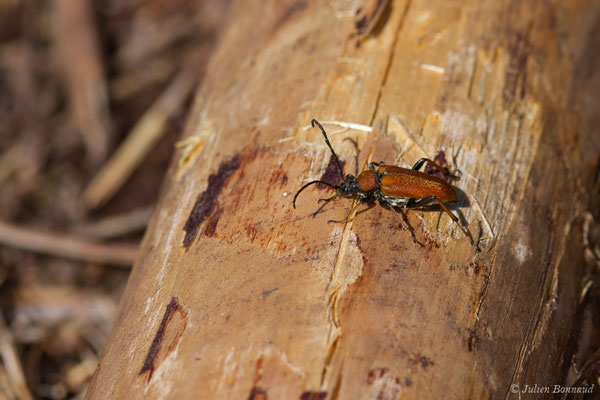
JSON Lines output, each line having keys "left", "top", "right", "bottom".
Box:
{"left": 0, "top": 0, "right": 228, "bottom": 399}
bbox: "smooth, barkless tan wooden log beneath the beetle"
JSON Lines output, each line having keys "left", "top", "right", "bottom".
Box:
{"left": 88, "top": 0, "right": 600, "bottom": 399}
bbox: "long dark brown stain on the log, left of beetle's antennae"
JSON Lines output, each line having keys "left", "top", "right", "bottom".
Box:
{"left": 183, "top": 155, "right": 240, "bottom": 249}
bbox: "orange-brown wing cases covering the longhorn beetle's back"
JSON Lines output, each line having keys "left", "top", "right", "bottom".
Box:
{"left": 379, "top": 168, "right": 458, "bottom": 201}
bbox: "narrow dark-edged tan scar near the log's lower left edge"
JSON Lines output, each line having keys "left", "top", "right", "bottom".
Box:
{"left": 139, "top": 296, "right": 187, "bottom": 382}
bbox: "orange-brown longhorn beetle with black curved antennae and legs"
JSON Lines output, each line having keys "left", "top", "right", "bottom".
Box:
{"left": 292, "top": 119, "right": 472, "bottom": 241}
